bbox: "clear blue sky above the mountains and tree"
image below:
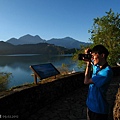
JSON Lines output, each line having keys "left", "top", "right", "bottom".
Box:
{"left": 0, "top": 0, "right": 120, "bottom": 42}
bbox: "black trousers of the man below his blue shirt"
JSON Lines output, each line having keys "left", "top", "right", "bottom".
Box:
{"left": 88, "top": 109, "right": 108, "bottom": 120}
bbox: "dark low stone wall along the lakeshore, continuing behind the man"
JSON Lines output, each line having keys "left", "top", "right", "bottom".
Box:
{"left": 0, "top": 67, "right": 120, "bottom": 119}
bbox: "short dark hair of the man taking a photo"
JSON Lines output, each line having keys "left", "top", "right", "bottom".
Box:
{"left": 92, "top": 45, "right": 109, "bottom": 58}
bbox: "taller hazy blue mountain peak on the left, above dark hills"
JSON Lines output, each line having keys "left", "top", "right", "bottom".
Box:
{"left": 7, "top": 34, "right": 46, "bottom": 45}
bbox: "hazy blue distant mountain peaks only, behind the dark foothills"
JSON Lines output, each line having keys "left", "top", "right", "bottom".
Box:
{"left": 6, "top": 34, "right": 90, "bottom": 49}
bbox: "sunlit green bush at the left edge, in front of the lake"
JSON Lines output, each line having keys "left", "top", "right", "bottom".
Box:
{"left": 0, "top": 72, "right": 12, "bottom": 91}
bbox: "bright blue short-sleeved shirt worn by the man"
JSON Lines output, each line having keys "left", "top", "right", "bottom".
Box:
{"left": 86, "top": 65, "right": 113, "bottom": 114}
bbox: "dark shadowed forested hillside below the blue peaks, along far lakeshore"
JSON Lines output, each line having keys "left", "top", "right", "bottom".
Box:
{"left": 0, "top": 41, "right": 75, "bottom": 55}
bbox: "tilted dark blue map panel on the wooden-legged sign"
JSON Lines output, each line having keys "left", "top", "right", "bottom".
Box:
{"left": 30, "top": 63, "right": 60, "bottom": 79}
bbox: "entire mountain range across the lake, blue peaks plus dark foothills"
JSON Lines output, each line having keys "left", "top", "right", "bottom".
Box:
{"left": 0, "top": 34, "right": 90, "bottom": 55}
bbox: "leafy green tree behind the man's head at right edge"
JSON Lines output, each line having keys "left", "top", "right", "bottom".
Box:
{"left": 89, "top": 9, "right": 120, "bottom": 66}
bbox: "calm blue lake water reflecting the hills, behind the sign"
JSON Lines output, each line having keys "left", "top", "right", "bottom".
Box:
{"left": 0, "top": 54, "right": 80, "bottom": 89}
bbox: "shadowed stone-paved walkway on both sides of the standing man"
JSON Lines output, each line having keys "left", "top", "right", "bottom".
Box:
{"left": 28, "top": 77, "right": 120, "bottom": 120}
